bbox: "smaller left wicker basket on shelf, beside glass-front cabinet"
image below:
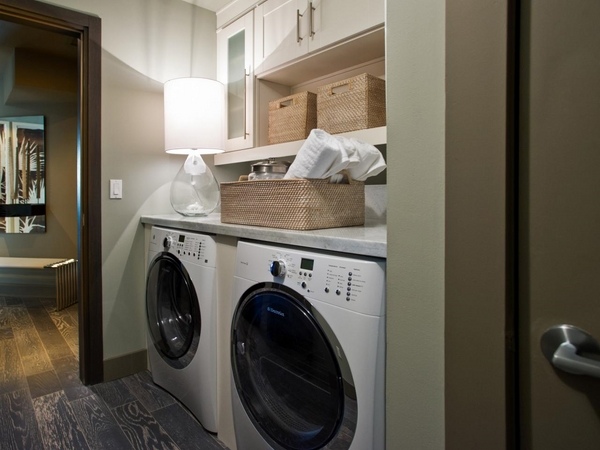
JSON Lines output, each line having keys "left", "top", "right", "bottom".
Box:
{"left": 269, "top": 91, "right": 317, "bottom": 144}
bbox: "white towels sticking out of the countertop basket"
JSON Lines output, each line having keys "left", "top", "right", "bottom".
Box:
{"left": 284, "top": 129, "right": 386, "bottom": 183}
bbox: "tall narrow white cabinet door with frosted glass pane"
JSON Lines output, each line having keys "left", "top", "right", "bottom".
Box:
{"left": 217, "top": 11, "right": 254, "bottom": 151}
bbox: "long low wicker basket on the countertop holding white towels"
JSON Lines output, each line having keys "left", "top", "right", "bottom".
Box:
{"left": 221, "top": 179, "right": 365, "bottom": 230}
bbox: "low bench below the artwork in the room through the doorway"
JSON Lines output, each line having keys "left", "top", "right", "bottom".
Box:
{"left": 0, "top": 256, "right": 77, "bottom": 311}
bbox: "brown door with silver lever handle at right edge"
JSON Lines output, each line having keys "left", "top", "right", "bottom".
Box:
{"left": 519, "top": 0, "right": 600, "bottom": 450}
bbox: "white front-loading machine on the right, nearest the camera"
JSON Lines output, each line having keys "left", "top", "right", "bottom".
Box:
{"left": 230, "top": 241, "right": 385, "bottom": 450}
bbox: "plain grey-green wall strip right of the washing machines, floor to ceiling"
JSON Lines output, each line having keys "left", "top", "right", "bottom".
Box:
{"left": 386, "top": 0, "right": 445, "bottom": 450}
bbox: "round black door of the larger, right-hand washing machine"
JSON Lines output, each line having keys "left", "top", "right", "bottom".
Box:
{"left": 231, "top": 283, "right": 356, "bottom": 449}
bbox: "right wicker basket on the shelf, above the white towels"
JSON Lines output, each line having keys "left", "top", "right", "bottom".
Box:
{"left": 317, "top": 73, "right": 386, "bottom": 134}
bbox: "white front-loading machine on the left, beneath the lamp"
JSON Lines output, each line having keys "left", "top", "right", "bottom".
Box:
{"left": 146, "top": 226, "right": 217, "bottom": 433}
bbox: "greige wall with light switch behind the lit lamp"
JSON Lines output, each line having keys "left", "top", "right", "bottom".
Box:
{"left": 38, "top": 0, "right": 216, "bottom": 360}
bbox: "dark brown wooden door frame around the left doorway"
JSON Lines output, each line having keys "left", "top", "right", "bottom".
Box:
{"left": 0, "top": 0, "right": 104, "bottom": 385}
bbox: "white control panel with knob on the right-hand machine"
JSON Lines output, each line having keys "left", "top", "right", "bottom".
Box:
{"left": 236, "top": 241, "right": 385, "bottom": 315}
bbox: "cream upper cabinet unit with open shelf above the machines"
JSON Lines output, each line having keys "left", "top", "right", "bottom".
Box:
{"left": 214, "top": 0, "right": 386, "bottom": 165}
